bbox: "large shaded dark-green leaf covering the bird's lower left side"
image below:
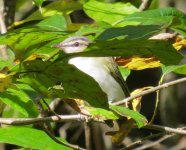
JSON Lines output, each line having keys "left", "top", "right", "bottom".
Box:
{"left": 21, "top": 60, "right": 108, "bottom": 109}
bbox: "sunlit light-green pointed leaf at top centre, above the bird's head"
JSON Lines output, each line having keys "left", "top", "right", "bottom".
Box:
{"left": 83, "top": 0, "right": 138, "bottom": 24}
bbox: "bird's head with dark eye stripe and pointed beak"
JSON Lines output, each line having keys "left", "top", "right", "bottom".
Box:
{"left": 53, "top": 36, "right": 90, "bottom": 53}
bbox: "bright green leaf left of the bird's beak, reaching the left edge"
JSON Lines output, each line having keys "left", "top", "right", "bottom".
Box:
{"left": 0, "top": 28, "right": 65, "bottom": 59}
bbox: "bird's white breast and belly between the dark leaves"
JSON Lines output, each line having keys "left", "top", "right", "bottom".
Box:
{"left": 68, "top": 57, "right": 125, "bottom": 101}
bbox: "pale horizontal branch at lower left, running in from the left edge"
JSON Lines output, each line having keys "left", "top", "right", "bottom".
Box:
{"left": 0, "top": 114, "right": 88, "bottom": 125}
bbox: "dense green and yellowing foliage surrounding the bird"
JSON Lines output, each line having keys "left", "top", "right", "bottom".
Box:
{"left": 0, "top": 0, "right": 186, "bottom": 150}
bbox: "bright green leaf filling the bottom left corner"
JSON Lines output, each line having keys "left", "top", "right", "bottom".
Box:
{"left": 0, "top": 127, "right": 71, "bottom": 150}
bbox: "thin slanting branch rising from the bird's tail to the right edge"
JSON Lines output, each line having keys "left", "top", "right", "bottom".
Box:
{"left": 112, "top": 77, "right": 186, "bottom": 105}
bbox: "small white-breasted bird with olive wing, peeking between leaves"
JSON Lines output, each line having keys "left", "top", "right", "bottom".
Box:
{"left": 53, "top": 36, "right": 129, "bottom": 103}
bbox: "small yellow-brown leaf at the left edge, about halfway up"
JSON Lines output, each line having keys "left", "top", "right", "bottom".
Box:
{"left": 0, "top": 73, "right": 12, "bottom": 92}
